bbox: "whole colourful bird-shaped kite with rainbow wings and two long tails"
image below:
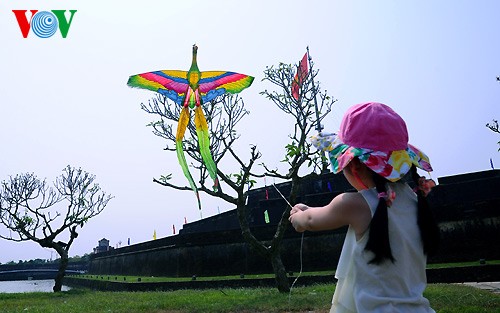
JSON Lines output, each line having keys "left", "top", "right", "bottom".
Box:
{"left": 127, "top": 45, "right": 254, "bottom": 210}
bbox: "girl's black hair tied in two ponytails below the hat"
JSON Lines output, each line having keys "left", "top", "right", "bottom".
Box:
{"left": 365, "top": 166, "right": 439, "bottom": 264}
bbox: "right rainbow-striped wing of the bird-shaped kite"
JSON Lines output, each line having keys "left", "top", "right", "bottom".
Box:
{"left": 198, "top": 71, "right": 254, "bottom": 102}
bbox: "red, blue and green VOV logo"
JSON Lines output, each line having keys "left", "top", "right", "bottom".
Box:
{"left": 12, "top": 10, "right": 77, "bottom": 38}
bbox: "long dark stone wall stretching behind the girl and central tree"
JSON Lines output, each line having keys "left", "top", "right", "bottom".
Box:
{"left": 89, "top": 170, "right": 500, "bottom": 277}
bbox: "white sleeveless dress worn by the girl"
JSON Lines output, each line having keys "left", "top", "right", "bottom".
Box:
{"left": 330, "top": 182, "right": 434, "bottom": 313}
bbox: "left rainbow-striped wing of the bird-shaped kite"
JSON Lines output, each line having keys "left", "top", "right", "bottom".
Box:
{"left": 127, "top": 70, "right": 189, "bottom": 104}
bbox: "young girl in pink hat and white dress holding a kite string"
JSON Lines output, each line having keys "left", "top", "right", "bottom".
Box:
{"left": 290, "top": 103, "right": 439, "bottom": 313}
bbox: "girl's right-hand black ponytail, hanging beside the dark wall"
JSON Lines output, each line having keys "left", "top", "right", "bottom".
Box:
{"left": 411, "top": 165, "right": 440, "bottom": 256}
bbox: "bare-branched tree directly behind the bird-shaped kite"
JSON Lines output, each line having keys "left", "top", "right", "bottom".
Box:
{"left": 141, "top": 50, "right": 333, "bottom": 292}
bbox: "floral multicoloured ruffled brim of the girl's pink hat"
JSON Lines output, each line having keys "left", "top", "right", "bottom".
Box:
{"left": 311, "top": 134, "right": 432, "bottom": 182}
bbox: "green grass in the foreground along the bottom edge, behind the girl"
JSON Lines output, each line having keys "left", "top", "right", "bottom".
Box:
{"left": 0, "top": 284, "right": 500, "bottom": 313}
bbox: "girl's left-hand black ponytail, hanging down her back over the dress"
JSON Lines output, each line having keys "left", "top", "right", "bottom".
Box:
{"left": 365, "top": 173, "right": 395, "bottom": 264}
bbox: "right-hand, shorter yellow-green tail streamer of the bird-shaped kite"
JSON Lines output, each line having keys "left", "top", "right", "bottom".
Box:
{"left": 194, "top": 106, "right": 219, "bottom": 191}
